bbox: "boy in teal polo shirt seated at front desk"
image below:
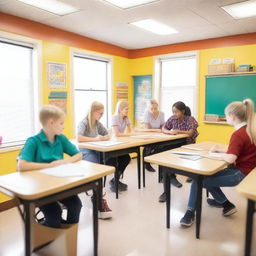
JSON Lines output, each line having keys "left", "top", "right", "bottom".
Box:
{"left": 18, "top": 105, "right": 82, "bottom": 228}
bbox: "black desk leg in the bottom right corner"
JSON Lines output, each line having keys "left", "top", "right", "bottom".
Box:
{"left": 244, "top": 199, "right": 255, "bottom": 256}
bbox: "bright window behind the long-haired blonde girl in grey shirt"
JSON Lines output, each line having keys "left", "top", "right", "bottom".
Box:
{"left": 73, "top": 54, "right": 111, "bottom": 129}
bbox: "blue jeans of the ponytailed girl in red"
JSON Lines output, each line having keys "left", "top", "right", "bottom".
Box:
{"left": 188, "top": 168, "right": 245, "bottom": 211}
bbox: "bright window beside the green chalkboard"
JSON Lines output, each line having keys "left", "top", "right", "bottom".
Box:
{"left": 156, "top": 53, "right": 198, "bottom": 118}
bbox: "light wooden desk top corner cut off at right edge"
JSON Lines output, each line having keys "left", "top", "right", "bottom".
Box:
{"left": 236, "top": 168, "right": 256, "bottom": 201}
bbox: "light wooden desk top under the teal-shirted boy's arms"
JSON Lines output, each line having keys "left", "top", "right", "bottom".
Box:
{"left": 0, "top": 160, "right": 115, "bottom": 200}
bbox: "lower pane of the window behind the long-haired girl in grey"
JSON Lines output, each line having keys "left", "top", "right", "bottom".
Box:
{"left": 74, "top": 91, "right": 107, "bottom": 133}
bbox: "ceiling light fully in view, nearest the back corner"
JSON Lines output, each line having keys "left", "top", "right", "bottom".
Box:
{"left": 130, "top": 19, "right": 178, "bottom": 35}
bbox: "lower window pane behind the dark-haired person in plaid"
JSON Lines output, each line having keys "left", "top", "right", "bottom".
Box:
{"left": 160, "top": 87, "right": 194, "bottom": 117}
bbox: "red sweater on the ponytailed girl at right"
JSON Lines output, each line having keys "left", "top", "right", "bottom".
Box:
{"left": 227, "top": 125, "right": 256, "bottom": 174}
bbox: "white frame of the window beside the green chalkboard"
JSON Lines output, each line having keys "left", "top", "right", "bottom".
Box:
{"left": 153, "top": 51, "right": 199, "bottom": 120}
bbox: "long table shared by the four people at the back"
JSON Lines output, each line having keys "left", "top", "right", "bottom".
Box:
{"left": 78, "top": 132, "right": 188, "bottom": 198}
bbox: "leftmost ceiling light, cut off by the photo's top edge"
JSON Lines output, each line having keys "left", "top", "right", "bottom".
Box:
{"left": 18, "top": 0, "right": 78, "bottom": 15}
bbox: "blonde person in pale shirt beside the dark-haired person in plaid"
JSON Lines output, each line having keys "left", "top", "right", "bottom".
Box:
{"left": 143, "top": 99, "right": 164, "bottom": 172}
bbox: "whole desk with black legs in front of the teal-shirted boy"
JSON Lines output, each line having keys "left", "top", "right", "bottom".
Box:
{"left": 0, "top": 160, "right": 115, "bottom": 256}
